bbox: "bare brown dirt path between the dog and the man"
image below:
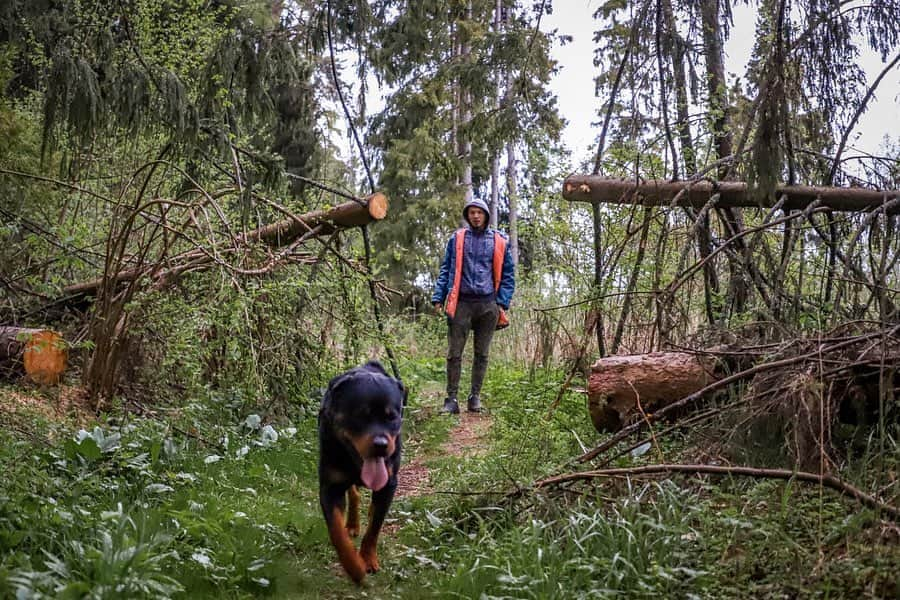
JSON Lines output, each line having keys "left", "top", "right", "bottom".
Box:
{"left": 396, "top": 411, "right": 491, "bottom": 498}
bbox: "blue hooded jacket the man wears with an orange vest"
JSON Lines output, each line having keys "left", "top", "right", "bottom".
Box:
{"left": 431, "top": 198, "right": 516, "bottom": 309}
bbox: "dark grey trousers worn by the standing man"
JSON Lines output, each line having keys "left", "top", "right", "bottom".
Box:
{"left": 447, "top": 301, "right": 500, "bottom": 398}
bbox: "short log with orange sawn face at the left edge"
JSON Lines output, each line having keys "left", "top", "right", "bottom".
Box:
{"left": 0, "top": 326, "right": 69, "bottom": 385}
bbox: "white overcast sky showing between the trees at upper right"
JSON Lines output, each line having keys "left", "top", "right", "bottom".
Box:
{"left": 541, "top": 0, "right": 900, "bottom": 171}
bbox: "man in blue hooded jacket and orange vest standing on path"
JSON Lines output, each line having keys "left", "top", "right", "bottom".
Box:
{"left": 431, "top": 199, "right": 516, "bottom": 414}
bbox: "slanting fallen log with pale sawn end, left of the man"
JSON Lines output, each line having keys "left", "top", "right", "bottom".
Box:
{"left": 63, "top": 192, "right": 388, "bottom": 299}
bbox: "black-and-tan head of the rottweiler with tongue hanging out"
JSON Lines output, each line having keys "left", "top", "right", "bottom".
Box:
{"left": 320, "top": 361, "right": 407, "bottom": 491}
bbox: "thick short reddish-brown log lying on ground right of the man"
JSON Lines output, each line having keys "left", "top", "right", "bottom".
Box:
{"left": 588, "top": 352, "right": 720, "bottom": 432}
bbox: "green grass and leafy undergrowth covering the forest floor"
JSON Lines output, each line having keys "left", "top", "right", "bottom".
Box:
{"left": 0, "top": 360, "right": 900, "bottom": 599}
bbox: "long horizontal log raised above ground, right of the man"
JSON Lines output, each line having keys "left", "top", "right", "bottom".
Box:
{"left": 563, "top": 175, "right": 900, "bottom": 214}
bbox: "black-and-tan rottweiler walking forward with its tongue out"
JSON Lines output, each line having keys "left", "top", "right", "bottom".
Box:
{"left": 319, "top": 361, "right": 407, "bottom": 583}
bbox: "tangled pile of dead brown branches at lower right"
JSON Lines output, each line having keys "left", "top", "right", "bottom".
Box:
{"left": 524, "top": 325, "right": 900, "bottom": 520}
